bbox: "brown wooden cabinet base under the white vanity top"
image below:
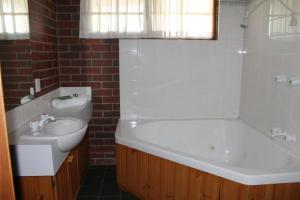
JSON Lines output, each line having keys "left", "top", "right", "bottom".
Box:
{"left": 15, "top": 134, "right": 89, "bottom": 200}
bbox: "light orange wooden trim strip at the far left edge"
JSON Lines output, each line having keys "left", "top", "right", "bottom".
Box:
{"left": 0, "top": 66, "right": 15, "bottom": 200}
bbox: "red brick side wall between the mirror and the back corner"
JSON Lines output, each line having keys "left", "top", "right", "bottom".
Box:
{"left": 28, "top": 0, "right": 59, "bottom": 94}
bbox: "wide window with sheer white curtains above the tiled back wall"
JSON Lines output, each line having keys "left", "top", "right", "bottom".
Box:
{"left": 80, "top": 0, "right": 218, "bottom": 39}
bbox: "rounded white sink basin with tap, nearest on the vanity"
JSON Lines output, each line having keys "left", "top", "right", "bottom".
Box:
{"left": 21, "top": 117, "right": 87, "bottom": 152}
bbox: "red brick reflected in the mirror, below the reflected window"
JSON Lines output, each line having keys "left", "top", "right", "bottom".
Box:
{"left": 0, "top": 40, "right": 33, "bottom": 110}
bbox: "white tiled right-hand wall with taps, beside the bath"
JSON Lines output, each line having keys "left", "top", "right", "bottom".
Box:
{"left": 240, "top": 0, "right": 300, "bottom": 153}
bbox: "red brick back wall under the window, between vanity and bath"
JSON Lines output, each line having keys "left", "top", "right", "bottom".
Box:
{"left": 57, "top": 0, "right": 120, "bottom": 165}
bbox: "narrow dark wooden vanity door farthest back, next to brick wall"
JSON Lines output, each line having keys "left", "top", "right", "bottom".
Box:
{"left": 78, "top": 133, "right": 89, "bottom": 183}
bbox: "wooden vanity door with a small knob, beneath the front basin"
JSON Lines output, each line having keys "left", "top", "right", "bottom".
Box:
{"left": 67, "top": 149, "right": 80, "bottom": 199}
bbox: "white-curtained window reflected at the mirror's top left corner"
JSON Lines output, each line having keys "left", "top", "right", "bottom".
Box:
{"left": 0, "top": 0, "right": 29, "bottom": 40}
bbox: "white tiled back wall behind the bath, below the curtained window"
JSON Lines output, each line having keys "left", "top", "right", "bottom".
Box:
{"left": 120, "top": 4, "right": 244, "bottom": 119}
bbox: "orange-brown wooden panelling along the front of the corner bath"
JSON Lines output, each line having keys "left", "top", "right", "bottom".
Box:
{"left": 116, "top": 144, "right": 300, "bottom": 200}
